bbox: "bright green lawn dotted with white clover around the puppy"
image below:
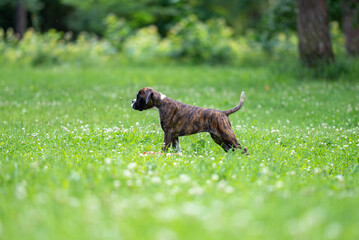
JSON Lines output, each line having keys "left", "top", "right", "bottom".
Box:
{"left": 0, "top": 62, "right": 359, "bottom": 240}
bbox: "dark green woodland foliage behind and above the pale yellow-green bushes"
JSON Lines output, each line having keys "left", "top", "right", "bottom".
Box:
{"left": 0, "top": 0, "right": 358, "bottom": 51}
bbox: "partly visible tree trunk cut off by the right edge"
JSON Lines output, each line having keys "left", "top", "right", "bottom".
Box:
{"left": 343, "top": 0, "right": 359, "bottom": 56}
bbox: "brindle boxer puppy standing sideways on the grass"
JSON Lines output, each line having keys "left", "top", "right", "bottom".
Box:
{"left": 131, "top": 87, "right": 247, "bottom": 154}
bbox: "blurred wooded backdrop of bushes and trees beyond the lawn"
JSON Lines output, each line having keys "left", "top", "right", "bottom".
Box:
{"left": 0, "top": 0, "right": 359, "bottom": 68}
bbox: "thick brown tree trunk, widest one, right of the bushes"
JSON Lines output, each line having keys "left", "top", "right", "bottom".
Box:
{"left": 297, "top": 0, "right": 334, "bottom": 67}
